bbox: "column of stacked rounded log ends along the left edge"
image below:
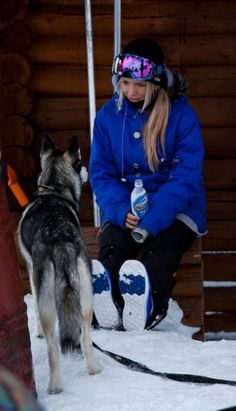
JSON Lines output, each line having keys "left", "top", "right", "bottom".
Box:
{"left": 0, "top": 0, "right": 38, "bottom": 210}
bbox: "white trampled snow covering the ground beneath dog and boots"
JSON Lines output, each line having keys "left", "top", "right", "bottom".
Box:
{"left": 25, "top": 294, "right": 236, "bottom": 411}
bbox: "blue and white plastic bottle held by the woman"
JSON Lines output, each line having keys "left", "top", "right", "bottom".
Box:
{"left": 131, "top": 178, "right": 148, "bottom": 219}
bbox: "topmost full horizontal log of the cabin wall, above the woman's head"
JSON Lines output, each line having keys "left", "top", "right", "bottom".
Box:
{"left": 25, "top": 11, "right": 236, "bottom": 37}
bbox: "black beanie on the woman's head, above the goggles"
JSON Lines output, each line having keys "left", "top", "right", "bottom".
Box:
{"left": 122, "top": 38, "right": 164, "bottom": 65}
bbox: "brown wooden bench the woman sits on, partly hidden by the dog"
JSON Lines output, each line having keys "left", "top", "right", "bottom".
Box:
{"left": 15, "top": 227, "right": 204, "bottom": 340}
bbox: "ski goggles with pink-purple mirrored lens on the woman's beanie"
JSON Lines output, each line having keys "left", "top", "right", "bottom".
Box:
{"left": 112, "top": 54, "right": 164, "bottom": 82}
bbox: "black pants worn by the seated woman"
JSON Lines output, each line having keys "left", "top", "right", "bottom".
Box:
{"left": 98, "top": 219, "right": 196, "bottom": 314}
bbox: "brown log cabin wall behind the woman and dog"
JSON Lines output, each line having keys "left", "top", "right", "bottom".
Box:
{"left": 0, "top": 0, "right": 236, "bottom": 340}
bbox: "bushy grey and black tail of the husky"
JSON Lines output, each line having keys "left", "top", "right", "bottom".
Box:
{"left": 53, "top": 244, "right": 81, "bottom": 354}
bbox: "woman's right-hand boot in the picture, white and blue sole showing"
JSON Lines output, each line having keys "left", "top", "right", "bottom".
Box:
{"left": 119, "top": 260, "right": 153, "bottom": 331}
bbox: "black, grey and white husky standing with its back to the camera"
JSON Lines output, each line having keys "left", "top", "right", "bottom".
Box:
{"left": 18, "top": 136, "right": 102, "bottom": 394}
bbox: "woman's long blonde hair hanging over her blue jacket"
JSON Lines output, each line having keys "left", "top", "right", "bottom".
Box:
{"left": 115, "top": 80, "right": 170, "bottom": 172}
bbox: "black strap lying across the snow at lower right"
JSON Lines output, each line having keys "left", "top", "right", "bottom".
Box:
{"left": 93, "top": 342, "right": 236, "bottom": 386}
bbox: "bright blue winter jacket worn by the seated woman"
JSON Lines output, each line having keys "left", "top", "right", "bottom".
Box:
{"left": 89, "top": 91, "right": 206, "bottom": 236}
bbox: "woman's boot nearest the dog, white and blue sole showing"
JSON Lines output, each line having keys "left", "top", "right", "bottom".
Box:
{"left": 92, "top": 260, "right": 121, "bottom": 328}
